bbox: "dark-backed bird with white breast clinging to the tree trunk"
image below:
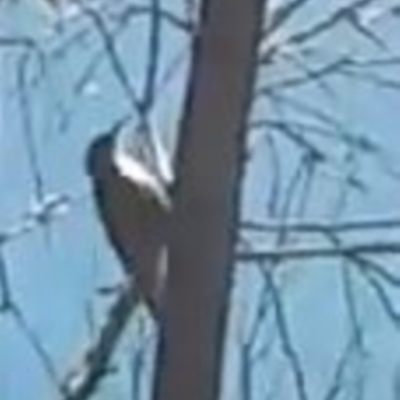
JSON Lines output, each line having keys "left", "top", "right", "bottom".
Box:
{"left": 86, "top": 120, "right": 173, "bottom": 317}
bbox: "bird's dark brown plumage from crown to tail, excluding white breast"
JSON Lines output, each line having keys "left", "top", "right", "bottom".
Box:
{"left": 86, "top": 134, "right": 169, "bottom": 313}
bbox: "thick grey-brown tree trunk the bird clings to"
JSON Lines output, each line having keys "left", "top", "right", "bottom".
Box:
{"left": 154, "top": 0, "right": 264, "bottom": 400}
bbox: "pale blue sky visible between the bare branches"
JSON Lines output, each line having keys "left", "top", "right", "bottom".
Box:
{"left": 0, "top": 0, "right": 400, "bottom": 400}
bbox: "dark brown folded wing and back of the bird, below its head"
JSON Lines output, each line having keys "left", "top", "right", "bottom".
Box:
{"left": 90, "top": 170, "right": 168, "bottom": 311}
